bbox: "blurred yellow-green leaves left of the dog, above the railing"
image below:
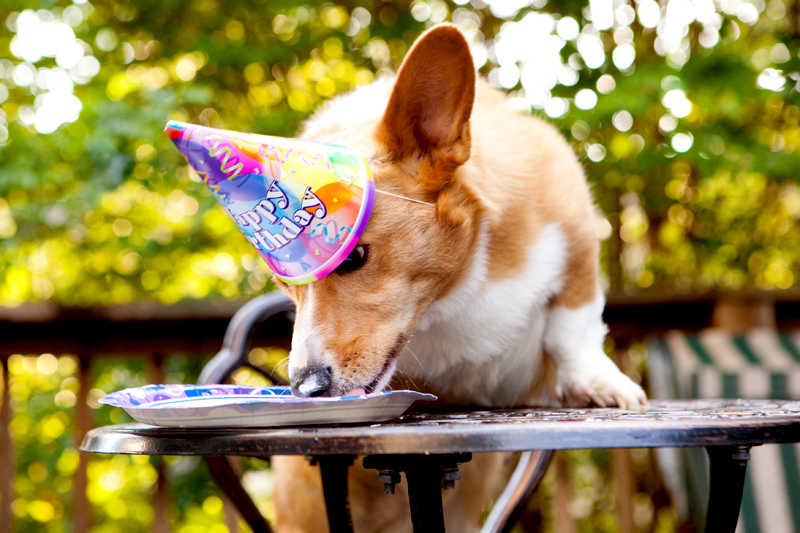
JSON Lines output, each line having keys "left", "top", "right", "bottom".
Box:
{"left": 0, "top": 1, "right": 421, "bottom": 305}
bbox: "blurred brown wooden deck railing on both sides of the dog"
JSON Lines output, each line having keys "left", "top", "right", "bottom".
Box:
{"left": 0, "top": 290, "right": 800, "bottom": 533}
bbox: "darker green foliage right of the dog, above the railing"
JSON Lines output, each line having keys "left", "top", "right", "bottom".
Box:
{"left": 572, "top": 12, "right": 800, "bottom": 291}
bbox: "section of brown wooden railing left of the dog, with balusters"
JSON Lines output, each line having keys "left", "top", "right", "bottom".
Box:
{"left": 0, "top": 301, "right": 291, "bottom": 533}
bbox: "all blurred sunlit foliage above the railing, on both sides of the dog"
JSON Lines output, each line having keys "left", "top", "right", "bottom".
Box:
{"left": 0, "top": 0, "right": 800, "bottom": 305}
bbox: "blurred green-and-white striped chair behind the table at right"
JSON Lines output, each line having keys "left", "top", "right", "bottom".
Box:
{"left": 648, "top": 329, "right": 800, "bottom": 533}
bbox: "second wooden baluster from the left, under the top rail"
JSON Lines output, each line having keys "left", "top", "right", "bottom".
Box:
{"left": 72, "top": 354, "right": 94, "bottom": 533}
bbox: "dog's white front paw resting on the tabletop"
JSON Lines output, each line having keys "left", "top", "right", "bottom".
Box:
{"left": 556, "top": 354, "right": 647, "bottom": 409}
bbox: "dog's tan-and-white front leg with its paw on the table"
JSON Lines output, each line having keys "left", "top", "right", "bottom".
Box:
{"left": 544, "top": 235, "right": 647, "bottom": 409}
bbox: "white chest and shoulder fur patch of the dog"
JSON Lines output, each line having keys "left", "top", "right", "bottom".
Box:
{"left": 398, "top": 224, "right": 567, "bottom": 405}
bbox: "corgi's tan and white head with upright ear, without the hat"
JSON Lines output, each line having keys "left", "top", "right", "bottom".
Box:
{"left": 278, "top": 25, "right": 482, "bottom": 396}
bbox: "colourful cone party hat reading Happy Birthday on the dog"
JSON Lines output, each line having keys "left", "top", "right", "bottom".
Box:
{"left": 165, "top": 120, "right": 375, "bottom": 285}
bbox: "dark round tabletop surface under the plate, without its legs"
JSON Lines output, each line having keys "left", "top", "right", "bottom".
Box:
{"left": 81, "top": 400, "right": 800, "bottom": 457}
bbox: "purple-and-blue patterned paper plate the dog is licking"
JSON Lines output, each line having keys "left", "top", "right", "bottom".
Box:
{"left": 99, "top": 385, "right": 436, "bottom": 427}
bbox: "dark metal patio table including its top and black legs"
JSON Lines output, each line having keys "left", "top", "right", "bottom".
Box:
{"left": 81, "top": 400, "right": 800, "bottom": 533}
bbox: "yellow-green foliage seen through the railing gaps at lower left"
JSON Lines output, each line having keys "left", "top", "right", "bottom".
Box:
{"left": 8, "top": 354, "right": 236, "bottom": 533}
